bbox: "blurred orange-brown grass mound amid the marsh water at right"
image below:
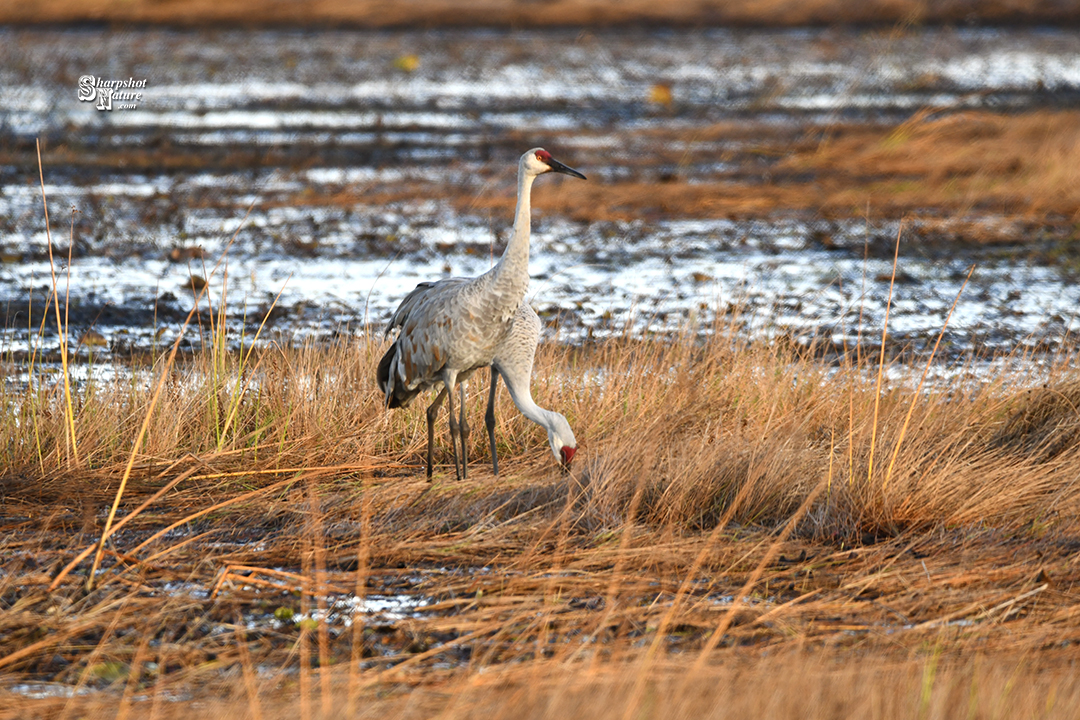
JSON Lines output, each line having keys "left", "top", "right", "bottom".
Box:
{"left": 785, "top": 110, "right": 1080, "bottom": 220}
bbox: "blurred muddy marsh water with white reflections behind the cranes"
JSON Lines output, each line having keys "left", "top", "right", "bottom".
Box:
{"left": 0, "top": 28, "right": 1080, "bottom": 362}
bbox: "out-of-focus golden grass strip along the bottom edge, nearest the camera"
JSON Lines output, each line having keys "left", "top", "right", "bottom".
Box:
{"left": 19, "top": 660, "right": 1080, "bottom": 720}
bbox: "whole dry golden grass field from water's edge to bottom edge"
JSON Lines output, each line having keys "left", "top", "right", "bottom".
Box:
{"left": 6, "top": 291, "right": 1080, "bottom": 718}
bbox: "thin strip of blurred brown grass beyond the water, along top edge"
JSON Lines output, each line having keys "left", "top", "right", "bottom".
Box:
{"left": 0, "top": 0, "right": 1080, "bottom": 28}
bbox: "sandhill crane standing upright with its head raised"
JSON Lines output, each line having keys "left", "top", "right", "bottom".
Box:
{"left": 376, "top": 148, "right": 585, "bottom": 479}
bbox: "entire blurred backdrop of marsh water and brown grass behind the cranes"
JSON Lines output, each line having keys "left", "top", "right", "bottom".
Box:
{"left": 0, "top": 0, "right": 1080, "bottom": 367}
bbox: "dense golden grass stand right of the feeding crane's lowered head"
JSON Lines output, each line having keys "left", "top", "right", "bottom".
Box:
{"left": 548, "top": 325, "right": 1080, "bottom": 539}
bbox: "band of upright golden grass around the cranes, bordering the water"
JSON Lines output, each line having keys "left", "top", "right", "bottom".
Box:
{"left": 2, "top": 315, "right": 1080, "bottom": 546}
